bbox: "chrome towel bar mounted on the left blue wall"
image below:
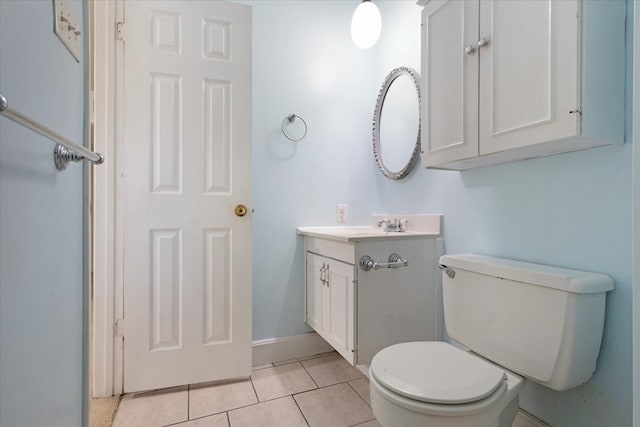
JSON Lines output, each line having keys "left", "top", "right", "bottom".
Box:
{"left": 0, "top": 93, "right": 104, "bottom": 170}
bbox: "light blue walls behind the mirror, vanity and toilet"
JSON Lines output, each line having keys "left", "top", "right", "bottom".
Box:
{"left": 247, "top": 1, "right": 632, "bottom": 427}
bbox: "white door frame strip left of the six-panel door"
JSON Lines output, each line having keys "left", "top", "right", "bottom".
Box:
{"left": 90, "top": 0, "right": 124, "bottom": 398}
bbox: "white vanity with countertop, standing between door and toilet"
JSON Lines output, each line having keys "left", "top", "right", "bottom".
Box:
{"left": 298, "top": 215, "right": 443, "bottom": 365}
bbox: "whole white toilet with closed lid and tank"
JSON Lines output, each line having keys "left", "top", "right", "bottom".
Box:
{"left": 369, "top": 254, "right": 613, "bottom": 427}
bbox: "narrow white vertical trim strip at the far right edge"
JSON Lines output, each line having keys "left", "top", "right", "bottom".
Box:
{"left": 631, "top": 2, "right": 640, "bottom": 427}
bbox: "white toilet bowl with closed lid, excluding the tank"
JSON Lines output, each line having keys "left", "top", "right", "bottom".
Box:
{"left": 369, "top": 342, "right": 525, "bottom": 427}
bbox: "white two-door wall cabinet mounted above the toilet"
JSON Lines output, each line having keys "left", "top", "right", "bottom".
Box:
{"left": 422, "top": 0, "right": 625, "bottom": 170}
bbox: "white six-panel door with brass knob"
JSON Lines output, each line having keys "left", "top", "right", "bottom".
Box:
{"left": 123, "top": 0, "right": 252, "bottom": 392}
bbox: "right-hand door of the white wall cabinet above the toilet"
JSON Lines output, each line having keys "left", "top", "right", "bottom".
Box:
{"left": 478, "top": 0, "right": 580, "bottom": 155}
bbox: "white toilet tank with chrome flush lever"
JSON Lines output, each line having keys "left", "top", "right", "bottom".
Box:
{"left": 440, "top": 254, "right": 613, "bottom": 391}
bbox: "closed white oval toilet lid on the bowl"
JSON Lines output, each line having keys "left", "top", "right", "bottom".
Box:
{"left": 371, "top": 341, "right": 506, "bottom": 404}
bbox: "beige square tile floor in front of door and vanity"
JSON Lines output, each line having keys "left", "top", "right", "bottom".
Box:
{"left": 113, "top": 352, "right": 543, "bottom": 427}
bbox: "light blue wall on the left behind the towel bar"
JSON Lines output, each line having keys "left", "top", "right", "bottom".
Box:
{"left": 0, "top": 0, "right": 84, "bottom": 427}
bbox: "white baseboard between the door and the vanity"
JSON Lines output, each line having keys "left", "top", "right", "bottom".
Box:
{"left": 253, "top": 332, "right": 333, "bottom": 366}
